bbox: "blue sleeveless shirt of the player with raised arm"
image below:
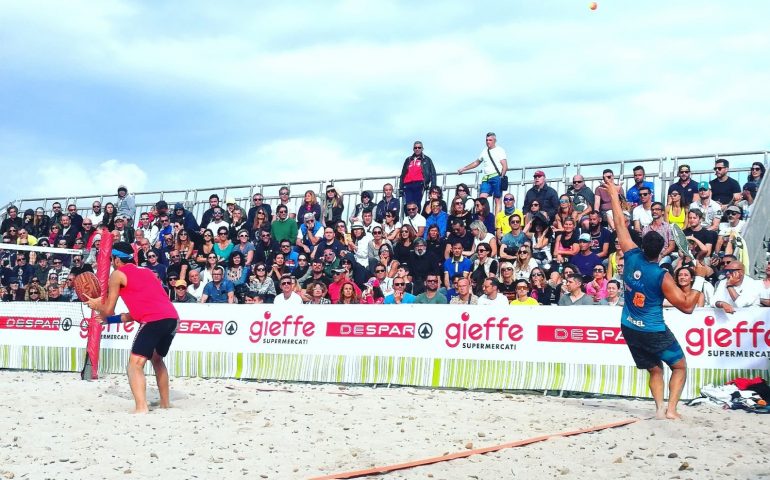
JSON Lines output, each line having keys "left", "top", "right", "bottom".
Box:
{"left": 620, "top": 248, "right": 666, "bottom": 332}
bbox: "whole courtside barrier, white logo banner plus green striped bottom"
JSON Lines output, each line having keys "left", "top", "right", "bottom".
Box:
{"left": 0, "top": 303, "right": 770, "bottom": 398}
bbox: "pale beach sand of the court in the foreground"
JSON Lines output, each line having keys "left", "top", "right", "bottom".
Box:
{"left": 0, "top": 371, "right": 770, "bottom": 480}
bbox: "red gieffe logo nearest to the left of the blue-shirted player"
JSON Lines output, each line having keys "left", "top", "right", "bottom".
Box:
{"left": 444, "top": 312, "right": 524, "bottom": 350}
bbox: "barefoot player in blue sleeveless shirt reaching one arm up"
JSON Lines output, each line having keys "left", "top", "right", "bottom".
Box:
{"left": 604, "top": 177, "right": 710, "bottom": 420}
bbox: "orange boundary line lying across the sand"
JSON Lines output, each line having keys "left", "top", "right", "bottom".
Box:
{"left": 310, "top": 418, "right": 639, "bottom": 480}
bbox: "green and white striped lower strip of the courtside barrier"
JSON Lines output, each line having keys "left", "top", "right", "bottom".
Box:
{"left": 0, "top": 345, "right": 768, "bottom": 398}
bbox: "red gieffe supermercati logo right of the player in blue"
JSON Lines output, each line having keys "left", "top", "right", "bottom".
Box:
{"left": 685, "top": 315, "right": 770, "bottom": 357}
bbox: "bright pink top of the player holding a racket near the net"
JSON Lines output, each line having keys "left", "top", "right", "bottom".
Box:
{"left": 118, "top": 263, "right": 179, "bottom": 323}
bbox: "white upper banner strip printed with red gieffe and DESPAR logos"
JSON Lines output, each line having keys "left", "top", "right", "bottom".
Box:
{"left": 0, "top": 303, "right": 770, "bottom": 370}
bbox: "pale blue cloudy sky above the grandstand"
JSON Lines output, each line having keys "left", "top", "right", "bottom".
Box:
{"left": 0, "top": 0, "right": 770, "bottom": 205}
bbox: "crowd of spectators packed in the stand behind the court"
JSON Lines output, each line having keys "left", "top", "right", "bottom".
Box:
{"left": 0, "top": 147, "right": 770, "bottom": 312}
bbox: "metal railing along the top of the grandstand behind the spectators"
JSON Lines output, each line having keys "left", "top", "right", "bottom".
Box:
{"left": 0, "top": 150, "right": 770, "bottom": 274}
